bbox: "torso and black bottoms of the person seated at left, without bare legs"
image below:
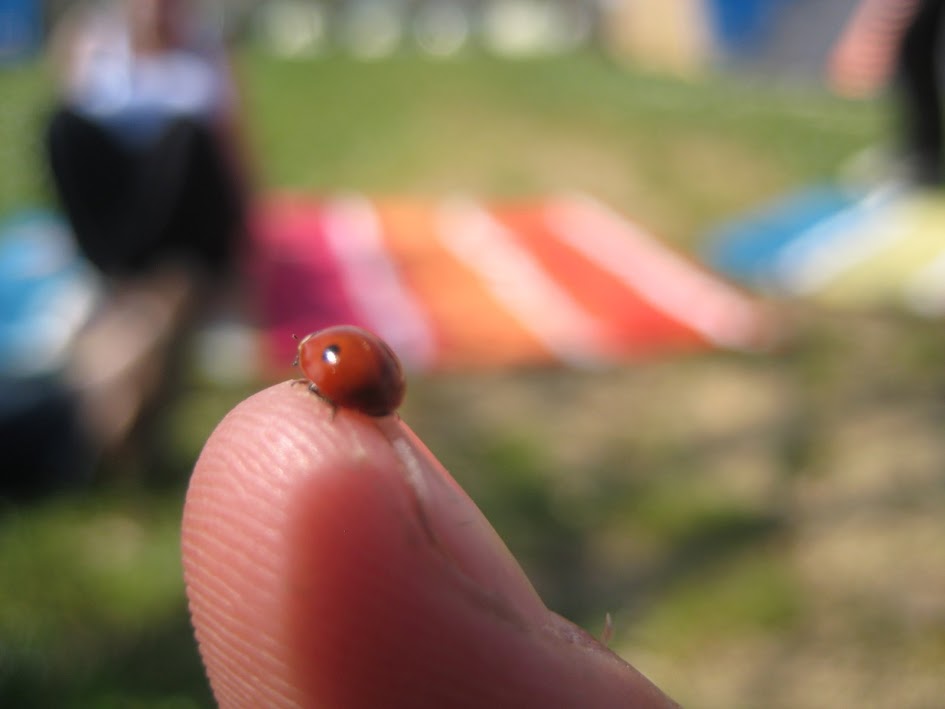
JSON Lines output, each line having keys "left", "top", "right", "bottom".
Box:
{"left": 47, "top": 0, "right": 245, "bottom": 276}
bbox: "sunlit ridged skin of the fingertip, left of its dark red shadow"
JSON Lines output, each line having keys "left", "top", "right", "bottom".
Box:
{"left": 181, "top": 383, "right": 390, "bottom": 706}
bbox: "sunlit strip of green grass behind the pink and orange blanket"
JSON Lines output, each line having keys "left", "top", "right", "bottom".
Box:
{"left": 243, "top": 53, "right": 883, "bottom": 243}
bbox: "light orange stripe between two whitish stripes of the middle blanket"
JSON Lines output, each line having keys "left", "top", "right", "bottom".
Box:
{"left": 375, "top": 200, "right": 551, "bottom": 369}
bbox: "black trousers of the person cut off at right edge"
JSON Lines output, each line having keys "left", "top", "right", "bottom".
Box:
{"left": 890, "top": 0, "right": 945, "bottom": 184}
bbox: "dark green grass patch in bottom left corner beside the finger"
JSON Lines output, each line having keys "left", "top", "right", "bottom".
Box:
{"left": 0, "top": 490, "right": 210, "bottom": 708}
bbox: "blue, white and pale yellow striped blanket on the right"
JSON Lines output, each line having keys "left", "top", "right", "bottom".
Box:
{"left": 707, "top": 185, "right": 945, "bottom": 317}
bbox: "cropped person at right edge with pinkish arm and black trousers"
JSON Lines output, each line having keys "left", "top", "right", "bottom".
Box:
{"left": 829, "top": 0, "right": 945, "bottom": 187}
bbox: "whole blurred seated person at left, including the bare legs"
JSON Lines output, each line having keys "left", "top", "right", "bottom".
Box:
{"left": 35, "top": 0, "right": 249, "bottom": 482}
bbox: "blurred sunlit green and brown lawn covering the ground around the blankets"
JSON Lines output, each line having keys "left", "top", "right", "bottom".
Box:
{"left": 0, "top": 47, "right": 945, "bottom": 708}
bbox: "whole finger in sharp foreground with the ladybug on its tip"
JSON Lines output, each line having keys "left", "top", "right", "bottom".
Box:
{"left": 182, "top": 382, "right": 676, "bottom": 709}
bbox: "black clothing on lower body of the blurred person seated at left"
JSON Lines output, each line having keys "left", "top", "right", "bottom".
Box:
{"left": 46, "top": 108, "right": 245, "bottom": 275}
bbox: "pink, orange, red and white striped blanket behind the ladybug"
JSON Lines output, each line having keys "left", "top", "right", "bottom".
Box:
{"left": 252, "top": 195, "right": 771, "bottom": 371}
